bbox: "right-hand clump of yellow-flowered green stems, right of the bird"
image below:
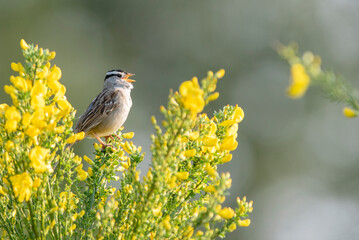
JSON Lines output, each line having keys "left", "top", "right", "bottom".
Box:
{"left": 132, "top": 70, "right": 253, "bottom": 239}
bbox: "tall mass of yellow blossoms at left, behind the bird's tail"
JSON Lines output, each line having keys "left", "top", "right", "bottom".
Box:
{"left": 0, "top": 39, "right": 73, "bottom": 202}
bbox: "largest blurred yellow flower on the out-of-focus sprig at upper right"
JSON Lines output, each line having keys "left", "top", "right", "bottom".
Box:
{"left": 287, "top": 63, "right": 310, "bottom": 98}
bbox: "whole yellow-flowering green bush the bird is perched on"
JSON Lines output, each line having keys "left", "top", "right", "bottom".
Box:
{"left": 0, "top": 40, "right": 252, "bottom": 239}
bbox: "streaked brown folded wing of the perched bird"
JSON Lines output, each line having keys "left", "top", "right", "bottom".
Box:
{"left": 75, "top": 89, "right": 120, "bottom": 133}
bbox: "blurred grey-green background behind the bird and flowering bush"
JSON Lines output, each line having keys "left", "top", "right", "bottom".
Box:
{"left": 0, "top": 0, "right": 359, "bottom": 240}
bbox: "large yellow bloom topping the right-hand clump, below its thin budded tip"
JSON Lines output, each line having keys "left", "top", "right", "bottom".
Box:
{"left": 179, "top": 80, "right": 205, "bottom": 113}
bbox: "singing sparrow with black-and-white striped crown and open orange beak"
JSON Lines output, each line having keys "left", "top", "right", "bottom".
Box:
{"left": 75, "top": 69, "right": 135, "bottom": 147}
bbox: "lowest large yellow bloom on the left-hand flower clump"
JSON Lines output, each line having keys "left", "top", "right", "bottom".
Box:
{"left": 10, "top": 172, "right": 33, "bottom": 202}
